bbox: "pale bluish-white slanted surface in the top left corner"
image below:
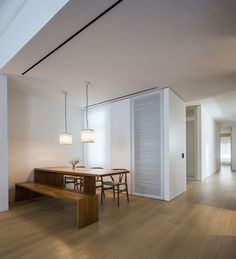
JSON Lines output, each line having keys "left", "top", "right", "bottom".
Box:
{"left": 0, "top": 0, "right": 68, "bottom": 69}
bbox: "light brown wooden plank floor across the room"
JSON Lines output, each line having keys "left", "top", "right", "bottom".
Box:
{"left": 0, "top": 169, "right": 236, "bottom": 259}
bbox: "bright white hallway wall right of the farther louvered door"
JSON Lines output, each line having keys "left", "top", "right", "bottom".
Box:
{"left": 201, "top": 105, "right": 220, "bottom": 180}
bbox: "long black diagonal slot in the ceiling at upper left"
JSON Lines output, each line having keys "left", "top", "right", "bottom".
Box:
{"left": 21, "top": 0, "right": 124, "bottom": 75}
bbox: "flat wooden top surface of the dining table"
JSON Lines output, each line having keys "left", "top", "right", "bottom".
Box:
{"left": 34, "top": 167, "right": 129, "bottom": 176}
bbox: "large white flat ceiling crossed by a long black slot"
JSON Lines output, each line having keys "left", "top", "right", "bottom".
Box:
{"left": 2, "top": 0, "right": 236, "bottom": 119}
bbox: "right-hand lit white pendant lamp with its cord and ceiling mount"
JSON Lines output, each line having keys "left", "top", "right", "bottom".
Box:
{"left": 81, "top": 81, "right": 95, "bottom": 143}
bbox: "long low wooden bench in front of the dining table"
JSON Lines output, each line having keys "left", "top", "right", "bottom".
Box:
{"left": 15, "top": 182, "right": 98, "bottom": 228}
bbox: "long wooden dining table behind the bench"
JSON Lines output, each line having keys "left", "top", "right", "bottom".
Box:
{"left": 34, "top": 167, "right": 129, "bottom": 195}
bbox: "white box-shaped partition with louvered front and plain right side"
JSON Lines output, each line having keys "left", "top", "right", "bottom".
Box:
{"left": 131, "top": 88, "right": 186, "bottom": 201}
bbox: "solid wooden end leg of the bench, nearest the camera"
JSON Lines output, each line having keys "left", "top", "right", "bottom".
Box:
{"left": 77, "top": 195, "right": 98, "bottom": 228}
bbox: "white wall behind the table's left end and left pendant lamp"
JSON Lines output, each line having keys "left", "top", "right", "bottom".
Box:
{"left": 8, "top": 81, "right": 83, "bottom": 200}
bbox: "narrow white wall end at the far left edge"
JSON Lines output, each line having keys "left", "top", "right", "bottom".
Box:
{"left": 0, "top": 75, "right": 8, "bottom": 211}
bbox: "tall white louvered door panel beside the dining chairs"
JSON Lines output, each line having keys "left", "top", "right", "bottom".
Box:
{"left": 131, "top": 91, "right": 164, "bottom": 199}
